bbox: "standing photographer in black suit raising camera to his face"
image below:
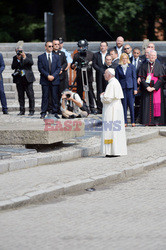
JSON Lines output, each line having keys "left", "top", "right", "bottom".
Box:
{"left": 11, "top": 43, "right": 35, "bottom": 116}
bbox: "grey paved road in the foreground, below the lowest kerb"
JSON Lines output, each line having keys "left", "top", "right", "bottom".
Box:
{"left": 0, "top": 167, "right": 166, "bottom": 250}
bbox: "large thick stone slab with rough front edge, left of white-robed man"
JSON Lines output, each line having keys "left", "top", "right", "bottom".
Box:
{"left": 0, "top": 116, "right": 85, "bottom": 145}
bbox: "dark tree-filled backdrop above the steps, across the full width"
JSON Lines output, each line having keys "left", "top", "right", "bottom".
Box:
{"left": 0, "top": 0, "right": 166, "bottom": 42}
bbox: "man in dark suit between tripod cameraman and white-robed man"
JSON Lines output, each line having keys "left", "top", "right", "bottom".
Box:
{"left": 92, "top": 41, "right": 108, "bottom": 114}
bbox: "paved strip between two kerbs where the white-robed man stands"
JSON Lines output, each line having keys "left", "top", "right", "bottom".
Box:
{"left": 0, "top": 133, "right": 166, "bottom": 200}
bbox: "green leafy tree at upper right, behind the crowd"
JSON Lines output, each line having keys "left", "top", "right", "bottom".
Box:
{"left": 97, "top": 0, "right": 166, "bottom": 40}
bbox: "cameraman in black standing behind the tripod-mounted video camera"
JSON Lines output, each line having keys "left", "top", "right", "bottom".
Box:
{"left": 71, "top": 39, "right": 97, "bottom": 114}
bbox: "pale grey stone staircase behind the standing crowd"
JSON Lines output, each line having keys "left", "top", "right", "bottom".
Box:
{"left": 0, "top": 42, "right": 166, "bottom": 112}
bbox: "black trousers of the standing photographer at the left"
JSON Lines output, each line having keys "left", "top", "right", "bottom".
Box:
{"left": 16, "top": 76, "right": 35, "bottom": 112}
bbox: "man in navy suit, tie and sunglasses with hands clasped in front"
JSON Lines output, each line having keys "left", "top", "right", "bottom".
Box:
{"left": 38, "top": 41, "right": 61, "bottom": 119}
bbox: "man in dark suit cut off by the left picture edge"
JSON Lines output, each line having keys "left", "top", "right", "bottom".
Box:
{"left": 0, "top": 53, "right": 8, "bottom": 115}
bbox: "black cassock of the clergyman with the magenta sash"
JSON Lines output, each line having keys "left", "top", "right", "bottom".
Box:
{"left": 138, "top": 61, "right": 165, "bottom": 125}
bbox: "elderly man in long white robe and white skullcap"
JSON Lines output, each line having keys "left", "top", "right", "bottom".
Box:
{"left": 100, "top": 68, "right": 127, "bottom": 157}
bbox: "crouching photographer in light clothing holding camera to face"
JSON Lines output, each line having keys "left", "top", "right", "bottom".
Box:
{"left": 61, "top": 89, "right": 89, "bottom": 119}
